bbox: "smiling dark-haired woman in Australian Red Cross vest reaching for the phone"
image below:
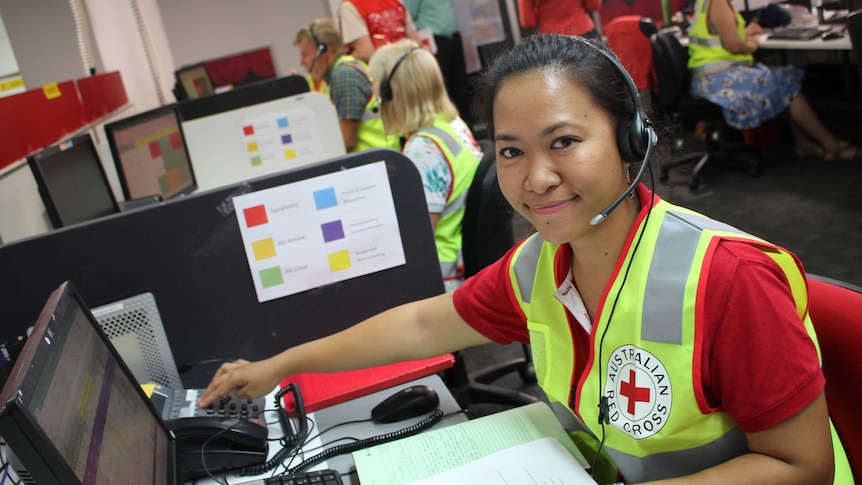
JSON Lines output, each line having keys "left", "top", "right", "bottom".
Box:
{"left": 200, "top": 34, "right": 852, "bottom": 485}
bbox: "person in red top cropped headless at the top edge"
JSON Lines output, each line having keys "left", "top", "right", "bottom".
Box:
{"left": 518, "top": 0, "right": 602, "bottom": 38}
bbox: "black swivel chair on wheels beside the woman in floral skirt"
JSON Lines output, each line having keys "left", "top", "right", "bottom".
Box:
{"left": 650, "top": 32, "right": 760, "bottom": 190}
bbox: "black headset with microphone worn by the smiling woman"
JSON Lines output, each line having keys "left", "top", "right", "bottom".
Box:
{"left": 588, "top": 37, "right": 658, "bottom": 225}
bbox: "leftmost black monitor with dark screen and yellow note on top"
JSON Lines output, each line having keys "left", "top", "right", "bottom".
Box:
{"left": 27, "top": 133, "right": 119, "bottom": 228}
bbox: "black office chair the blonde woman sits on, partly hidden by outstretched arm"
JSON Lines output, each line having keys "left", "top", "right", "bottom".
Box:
{"left": 445, "top": 139, "right": 538, "bottom": 408}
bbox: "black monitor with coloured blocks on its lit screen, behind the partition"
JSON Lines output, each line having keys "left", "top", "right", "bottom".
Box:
{"left": 105, "top": 104, "right": 197, "bottom": 200}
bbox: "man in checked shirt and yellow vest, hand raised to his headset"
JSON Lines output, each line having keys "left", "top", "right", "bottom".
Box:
{"left": 293, "top": 18, "right": 401, "bottom": 153}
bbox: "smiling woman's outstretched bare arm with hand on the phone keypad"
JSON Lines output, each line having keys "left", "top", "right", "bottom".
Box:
{"left": 198, "top": 293, "right": 490, "bottom": 407}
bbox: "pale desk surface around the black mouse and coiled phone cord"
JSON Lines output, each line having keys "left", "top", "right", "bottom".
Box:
{"left": 190, "top": 375, "right": 467, "bottom": 485}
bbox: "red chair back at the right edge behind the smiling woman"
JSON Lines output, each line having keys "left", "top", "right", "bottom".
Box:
{"left": 808, "top": 274, "right": 862, "bottom": 483}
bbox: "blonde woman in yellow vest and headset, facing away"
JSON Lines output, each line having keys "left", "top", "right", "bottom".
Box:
{"left": 370, "top": 39, "right": 482, "bottom": 290}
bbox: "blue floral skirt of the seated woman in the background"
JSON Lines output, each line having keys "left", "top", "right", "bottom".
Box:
{"left": 691, "top": 63, "right": 805, "bottom": 130}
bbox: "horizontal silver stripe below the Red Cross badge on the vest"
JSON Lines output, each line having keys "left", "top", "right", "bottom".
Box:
{"left": 608, "top": 428, "right": 748, "bottom": 483}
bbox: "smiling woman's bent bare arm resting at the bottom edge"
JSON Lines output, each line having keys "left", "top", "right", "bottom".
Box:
{"left": 650, "top": 393, "right": 834, "bottom": 485}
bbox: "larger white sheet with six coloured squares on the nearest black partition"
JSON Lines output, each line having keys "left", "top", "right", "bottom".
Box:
{"left": 233, "top": 161, "right": 406, "bottom": 302}
